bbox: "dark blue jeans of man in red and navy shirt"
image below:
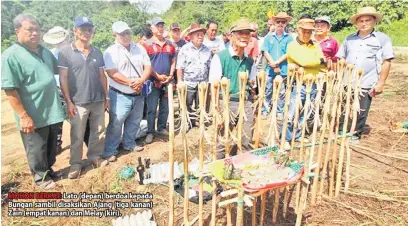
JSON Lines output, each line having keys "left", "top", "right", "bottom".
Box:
{"left": 147, "top": 86, "right": 169, "bottom": 133}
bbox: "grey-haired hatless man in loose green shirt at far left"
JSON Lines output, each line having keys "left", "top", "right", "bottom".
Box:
{"left": 1, "top": 14, "right": 65, "bottom": 189}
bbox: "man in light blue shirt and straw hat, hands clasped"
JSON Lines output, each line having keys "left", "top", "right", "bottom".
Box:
{"left": 262, "top": 12, "right": 293, "bottom": 118}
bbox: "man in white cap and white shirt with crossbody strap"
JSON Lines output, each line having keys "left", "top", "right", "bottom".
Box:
{"left": 103, "top": 21, "right": 151, "bottom": 162}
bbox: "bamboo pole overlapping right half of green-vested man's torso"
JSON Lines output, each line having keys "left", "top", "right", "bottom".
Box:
{"left": 237, "top": 72, "right": 248, "bottom": 153}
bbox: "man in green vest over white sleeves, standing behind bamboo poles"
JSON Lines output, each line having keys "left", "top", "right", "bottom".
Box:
{"left": 209, "top": 19, "right": 256, "bottom": 158}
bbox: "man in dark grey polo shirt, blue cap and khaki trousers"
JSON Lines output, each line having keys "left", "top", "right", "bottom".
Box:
{"left": 58, "top": 16, "right": 109, "bottom": 179}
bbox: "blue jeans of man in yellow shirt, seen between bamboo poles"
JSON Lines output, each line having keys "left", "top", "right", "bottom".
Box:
{"left": 281, "top": 84, "right": 317, "bottom": 141}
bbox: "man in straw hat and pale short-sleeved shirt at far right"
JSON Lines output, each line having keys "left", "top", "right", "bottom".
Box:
{"left": 337, "top": 7, "right": 394, "bottom": 143}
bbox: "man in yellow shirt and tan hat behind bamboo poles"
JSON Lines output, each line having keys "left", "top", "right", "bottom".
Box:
{"left": 285, "top": 16, "right": 327, "bottom": 149}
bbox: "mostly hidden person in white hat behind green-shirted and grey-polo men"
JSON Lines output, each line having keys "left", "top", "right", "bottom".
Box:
{"left": 43, "top": 26, "right": 69, "bottom": 153}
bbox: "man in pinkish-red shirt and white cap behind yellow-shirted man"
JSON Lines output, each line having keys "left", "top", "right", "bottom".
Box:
{"left": 314, "top": 16, "right": 339, "bottom": 71}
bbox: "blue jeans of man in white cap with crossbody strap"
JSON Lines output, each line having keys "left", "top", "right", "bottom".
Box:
{"left": 103, "top": 90, "right": 144, "bottom": 158}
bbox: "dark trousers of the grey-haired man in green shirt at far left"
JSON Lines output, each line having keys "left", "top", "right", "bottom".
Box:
{"left": 20, "top": 123, "right": 61, "bottom": 185}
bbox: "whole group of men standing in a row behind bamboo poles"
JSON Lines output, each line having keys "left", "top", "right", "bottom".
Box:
{"left": 2, "top": 7, "right": 394, "bottom": 189}
